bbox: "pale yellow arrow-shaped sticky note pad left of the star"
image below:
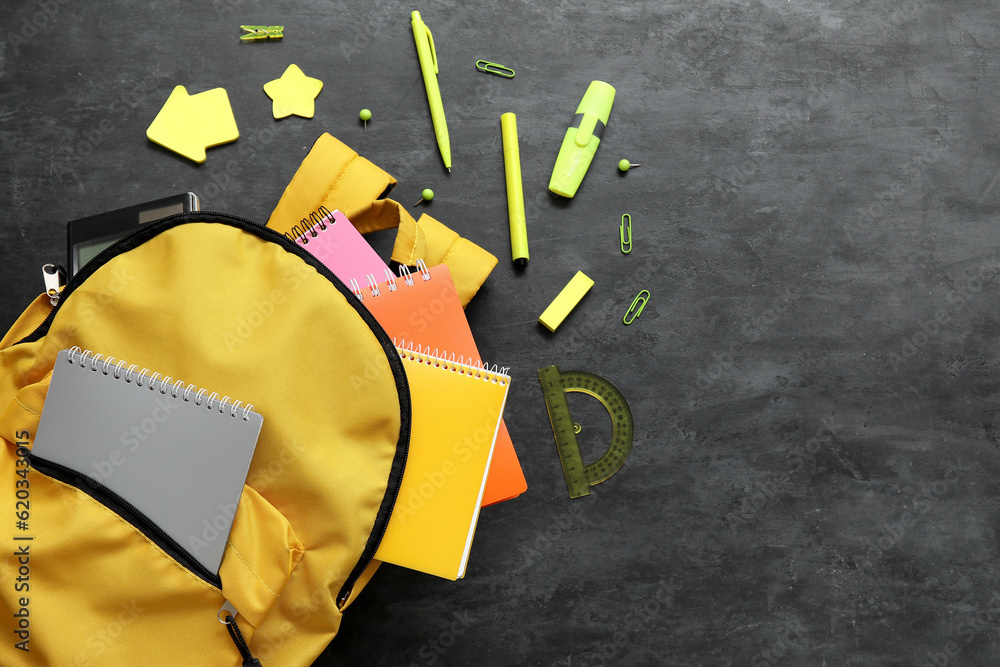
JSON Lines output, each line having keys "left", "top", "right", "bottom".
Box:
{"left": 146, "top": 86, "right": 240, "bottom": 162}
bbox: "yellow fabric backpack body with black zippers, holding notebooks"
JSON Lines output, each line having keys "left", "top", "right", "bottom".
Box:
{"left": 0, "top": 213, "right": 410, "bottom": 667}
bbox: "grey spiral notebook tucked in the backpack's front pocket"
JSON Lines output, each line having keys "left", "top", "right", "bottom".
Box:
{"left": 31, "top": 349, "right": 263, "bottom": 573}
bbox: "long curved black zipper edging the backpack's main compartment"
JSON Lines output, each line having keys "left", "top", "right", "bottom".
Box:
{"left": 15, "top": 211, "right": 411, "bottom": 609}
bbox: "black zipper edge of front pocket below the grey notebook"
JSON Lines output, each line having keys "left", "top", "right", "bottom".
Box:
{"left": 28, "top": 453, "right": 222, "bottom": 590}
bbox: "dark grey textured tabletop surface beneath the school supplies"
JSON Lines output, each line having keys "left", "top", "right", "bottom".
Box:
{"left": 0, "top": 0, "right": 1000, "bottom": 667}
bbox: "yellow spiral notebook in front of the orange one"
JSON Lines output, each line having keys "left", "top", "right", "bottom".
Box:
{"left": 375, "top": 343, "right": 510, "bottom": 580}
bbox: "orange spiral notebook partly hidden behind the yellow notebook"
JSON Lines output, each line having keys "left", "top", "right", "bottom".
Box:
{"left": 355, "top": 261, "right": 528, "bottom": 507}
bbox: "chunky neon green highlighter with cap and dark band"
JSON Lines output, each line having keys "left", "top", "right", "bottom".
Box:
{"left": 549, "top": 81, "right": 615, "bottom": 197}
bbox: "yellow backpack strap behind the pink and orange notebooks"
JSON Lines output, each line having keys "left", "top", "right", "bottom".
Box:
{"left": 267, "top": 133, "right": 497, "bottom": 307}
